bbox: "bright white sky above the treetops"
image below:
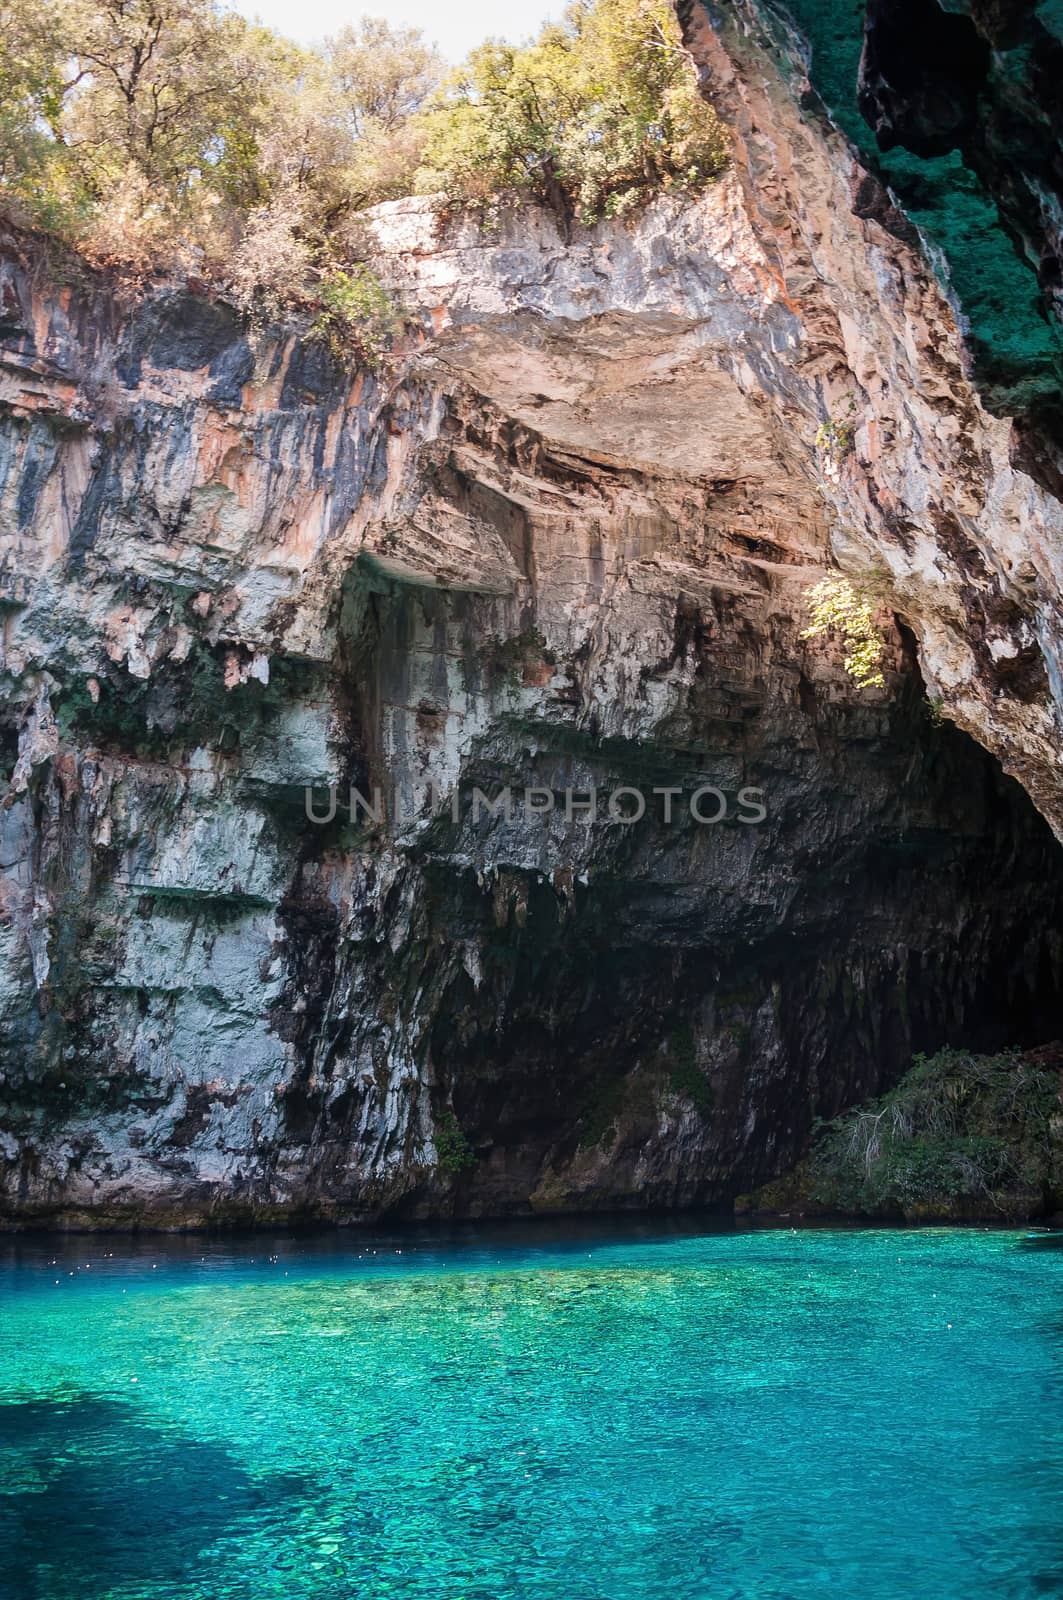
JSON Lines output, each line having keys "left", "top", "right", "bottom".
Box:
{"left": 232, "top": 0, "right": 564, "bottom": 61}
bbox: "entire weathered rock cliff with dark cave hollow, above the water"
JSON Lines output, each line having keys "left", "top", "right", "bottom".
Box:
{"left": 0, "top": 6, "right": 1063, "bottom": 1224}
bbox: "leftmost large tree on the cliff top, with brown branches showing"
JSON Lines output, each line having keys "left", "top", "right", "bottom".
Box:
{"left": 0, "top": 0, "right": 286, "bottom": 266}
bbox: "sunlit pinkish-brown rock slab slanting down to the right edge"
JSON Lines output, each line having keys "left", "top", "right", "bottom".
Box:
{"left": 687, "top": 0, "right": 1063, "bottom": 834}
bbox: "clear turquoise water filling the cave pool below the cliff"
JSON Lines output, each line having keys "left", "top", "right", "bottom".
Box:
{"left": 0, "top": 1229, "right": 1063, "bottom": 1600}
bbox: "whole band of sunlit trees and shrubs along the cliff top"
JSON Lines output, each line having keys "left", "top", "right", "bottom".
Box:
{"left": 0, "top": 0, "right": 727, "bottom": 324}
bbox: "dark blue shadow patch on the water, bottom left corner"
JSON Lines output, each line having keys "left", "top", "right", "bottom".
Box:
{"left": 0, "top": 1394, "right": 309, "bottom": 1600}
